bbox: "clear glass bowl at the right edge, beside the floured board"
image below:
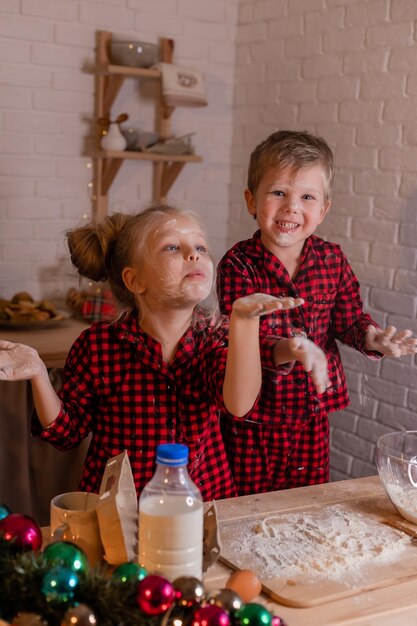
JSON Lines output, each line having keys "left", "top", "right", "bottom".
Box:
{"left": 375, "top": 430, "right": 417, "bottom": 524}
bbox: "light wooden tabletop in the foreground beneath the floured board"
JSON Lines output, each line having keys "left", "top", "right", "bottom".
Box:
{"left": 205, "top": 476, "right": 417, "bottom": 626}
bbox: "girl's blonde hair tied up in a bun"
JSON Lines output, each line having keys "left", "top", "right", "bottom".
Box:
{"left": 67, "top": 204, "right": 217, "bottom": 318}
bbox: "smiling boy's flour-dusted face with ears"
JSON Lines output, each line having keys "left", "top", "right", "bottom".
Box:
{"left": 245, "top": 165, "right": 330, "bottom": 258}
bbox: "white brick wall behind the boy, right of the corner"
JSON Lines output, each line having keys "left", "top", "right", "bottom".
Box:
{"left": 229, "top": 0, "right": 417, "bottom": 479}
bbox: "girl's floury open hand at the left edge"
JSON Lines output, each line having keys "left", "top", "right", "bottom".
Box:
{"left": 0, "top": 339, "right": 46, "bottom": 381}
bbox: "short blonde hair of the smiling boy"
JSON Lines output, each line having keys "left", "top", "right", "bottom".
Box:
{"left": 248, "top": 130, "right": 334, "bottom": 201}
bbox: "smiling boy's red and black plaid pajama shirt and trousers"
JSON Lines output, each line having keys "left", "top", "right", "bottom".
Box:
{"left": 217, "top": 231, "right": 381, "bottom": 494}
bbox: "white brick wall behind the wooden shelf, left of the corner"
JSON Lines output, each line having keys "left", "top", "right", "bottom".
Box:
{"left": 0, "top": 0, "right": 238, "bottom": 298}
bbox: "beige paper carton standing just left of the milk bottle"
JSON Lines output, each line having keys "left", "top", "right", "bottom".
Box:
{"left": 96, "top": 450, "right": 138, "bottom": 565}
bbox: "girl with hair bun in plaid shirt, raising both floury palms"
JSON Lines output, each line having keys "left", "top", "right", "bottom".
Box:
{"left": 0, "top": 205, "right": 302, "bottom": 500}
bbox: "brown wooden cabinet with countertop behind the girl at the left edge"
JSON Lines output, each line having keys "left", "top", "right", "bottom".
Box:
{"left": 0, "top": 318, "right": 88, "bottom": 524}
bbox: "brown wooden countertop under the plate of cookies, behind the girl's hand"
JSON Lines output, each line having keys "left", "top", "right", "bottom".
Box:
{"left": 0, "top": 317, "right": 89, "bottom": 367}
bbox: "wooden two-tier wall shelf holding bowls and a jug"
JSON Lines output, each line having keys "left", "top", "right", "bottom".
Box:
{"left": 92, "top": 31, "right": 202, "bottom": 219}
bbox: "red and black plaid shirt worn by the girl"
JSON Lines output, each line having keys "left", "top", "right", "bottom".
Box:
{"left": 32, "top": 317, "right": 236, "bottom": 500}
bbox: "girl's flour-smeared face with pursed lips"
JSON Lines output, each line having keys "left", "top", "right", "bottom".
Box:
{"left": 124, "top": 215, "right": 213, "bottom": 309}
